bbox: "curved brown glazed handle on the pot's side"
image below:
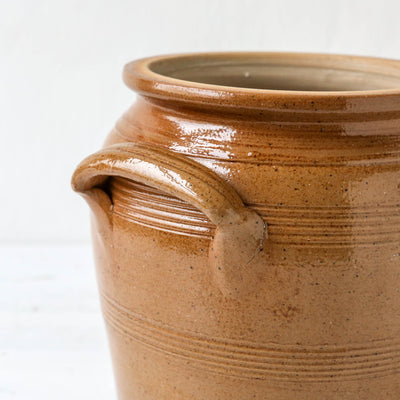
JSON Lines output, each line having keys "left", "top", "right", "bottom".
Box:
{"left": 72, "top": 143, "right": 266, "bottom": 298}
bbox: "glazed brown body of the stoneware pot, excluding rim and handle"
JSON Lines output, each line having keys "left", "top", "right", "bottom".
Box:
{"left": 72, "top": 52, "right": 400, "bottom": 400}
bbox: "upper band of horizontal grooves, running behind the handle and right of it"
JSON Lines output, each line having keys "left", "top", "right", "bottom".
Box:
{"left": 111, "top": 178, "right": 400, "bottom": 246}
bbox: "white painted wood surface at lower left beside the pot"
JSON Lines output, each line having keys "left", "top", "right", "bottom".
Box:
{"left": 0, "top": 245, "right": 116, "bottom": 400}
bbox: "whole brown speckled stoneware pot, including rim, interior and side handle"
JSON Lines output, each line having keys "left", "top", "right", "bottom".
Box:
{"left": 73, "top": 53, "right": 400, "bottom": 400}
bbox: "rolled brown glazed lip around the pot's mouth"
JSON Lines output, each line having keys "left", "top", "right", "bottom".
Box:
{"left": 123, "top": 52, "right": 400, "bottom": 113}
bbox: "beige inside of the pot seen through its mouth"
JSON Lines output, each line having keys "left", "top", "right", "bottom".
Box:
{"left": 149, "top": 55, "right": 400, "bottom": 92}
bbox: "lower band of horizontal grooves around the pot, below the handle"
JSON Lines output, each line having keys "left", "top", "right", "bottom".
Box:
{"left": 102, "top": 293, "right": 400, "bottom": 381}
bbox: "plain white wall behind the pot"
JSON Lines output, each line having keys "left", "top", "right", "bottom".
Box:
{"left": 0, "top": 0, "right": 400, "bottom": 243}
